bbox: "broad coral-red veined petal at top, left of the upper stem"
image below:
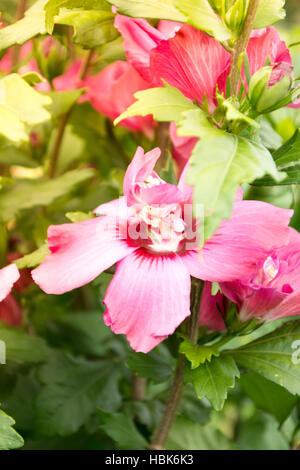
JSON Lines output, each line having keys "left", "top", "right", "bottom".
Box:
{"left": 150, "top": 25, "right": 230, "bottom": 107}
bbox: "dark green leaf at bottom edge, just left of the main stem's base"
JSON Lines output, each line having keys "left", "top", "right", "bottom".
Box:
{"left": 100, "top": 411, "right": 147, "bottom": 450}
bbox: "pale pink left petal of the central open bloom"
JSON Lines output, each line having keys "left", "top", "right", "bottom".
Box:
{"left": 32, "top": 217, "right": 136, "bottom": 294}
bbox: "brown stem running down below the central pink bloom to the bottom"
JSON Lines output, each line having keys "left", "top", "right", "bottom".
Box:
{"left": 151, "top": 278, "right": 203, "bottom": 450}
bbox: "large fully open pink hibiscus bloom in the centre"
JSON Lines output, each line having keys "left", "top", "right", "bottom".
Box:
{"left": 32, "top": 148, "right": 292, "bottom": 352}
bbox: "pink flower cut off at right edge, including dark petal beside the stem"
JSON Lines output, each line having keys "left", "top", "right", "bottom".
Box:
{"left": 199, "top": 228, "right": 300, "bottom": 331}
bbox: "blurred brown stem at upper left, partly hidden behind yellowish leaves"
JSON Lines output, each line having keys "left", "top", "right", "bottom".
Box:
{"left": 48, "top": 49, "right": 94, "bottom": 178}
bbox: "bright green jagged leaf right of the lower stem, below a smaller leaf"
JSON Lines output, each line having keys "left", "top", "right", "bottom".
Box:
{"left": 184, "top": 356, "right": 240, "bottom": 410}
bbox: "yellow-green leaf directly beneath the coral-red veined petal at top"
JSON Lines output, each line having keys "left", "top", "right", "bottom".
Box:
{"left": 114, "top": 84, "right": 197, "bottom": 125}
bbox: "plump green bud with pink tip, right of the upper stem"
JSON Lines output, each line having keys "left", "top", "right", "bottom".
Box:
{"left": 249, "top": 62, "right": 293, "bottom": 113}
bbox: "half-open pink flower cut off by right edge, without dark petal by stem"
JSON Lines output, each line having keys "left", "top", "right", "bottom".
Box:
{"left": 221, "top": 228, "right": 300, "bottom": 321}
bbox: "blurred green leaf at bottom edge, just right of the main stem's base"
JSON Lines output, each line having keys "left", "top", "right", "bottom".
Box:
{"left": 166, "top": 416, "right": 232, "bottom": 450}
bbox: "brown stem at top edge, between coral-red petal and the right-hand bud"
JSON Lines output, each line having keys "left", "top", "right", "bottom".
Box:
{"left": 230, "top": 0, "right": 259, "bottom": 96}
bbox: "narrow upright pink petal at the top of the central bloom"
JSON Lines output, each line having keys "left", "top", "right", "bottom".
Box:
{"left": 123, "top": 147, "right": 161, "bottom": 205}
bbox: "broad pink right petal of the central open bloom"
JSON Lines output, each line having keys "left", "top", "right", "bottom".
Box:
{"left": 182, "top": 201, "right": 293, "bottom": 282}
